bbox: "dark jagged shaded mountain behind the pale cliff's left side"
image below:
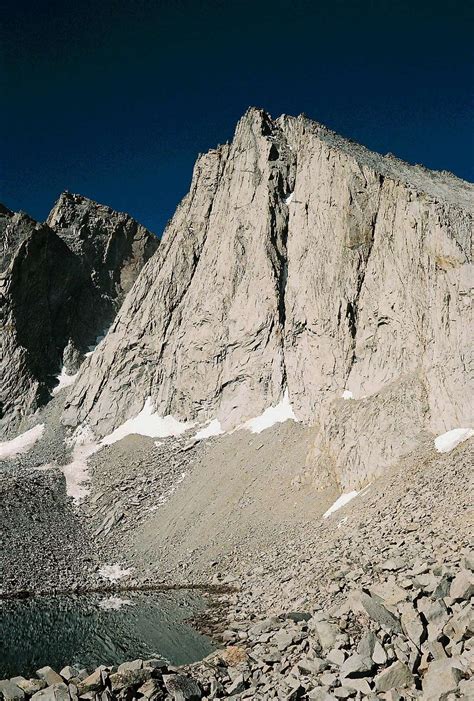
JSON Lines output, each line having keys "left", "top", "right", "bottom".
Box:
{"left": 0, "top": 193, "right": 158, "bottom": 431}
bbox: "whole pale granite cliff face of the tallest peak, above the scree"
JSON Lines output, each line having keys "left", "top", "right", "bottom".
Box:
{"left": 65, "top": 110, "right": 473, "bottom": 481}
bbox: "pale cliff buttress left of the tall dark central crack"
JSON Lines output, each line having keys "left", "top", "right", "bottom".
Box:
{"left": 62, "top": 111, "right": 294, "bottom": 433}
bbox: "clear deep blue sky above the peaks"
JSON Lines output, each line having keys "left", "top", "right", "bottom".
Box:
{"left": 0, "top": 0, "right": 474, "bottom": 234}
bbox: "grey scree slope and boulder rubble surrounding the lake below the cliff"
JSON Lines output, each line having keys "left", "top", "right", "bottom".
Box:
{"left": 0, "top": 394, "right": 474, "bottom": 701}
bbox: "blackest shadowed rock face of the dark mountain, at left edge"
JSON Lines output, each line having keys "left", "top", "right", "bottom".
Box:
{"left": 0, "top": 213, "right": 87, "bottom": 434}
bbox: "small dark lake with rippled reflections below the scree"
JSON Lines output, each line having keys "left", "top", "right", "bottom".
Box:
{"left": 0, "top": 591, "right": 215, "bottom": 679}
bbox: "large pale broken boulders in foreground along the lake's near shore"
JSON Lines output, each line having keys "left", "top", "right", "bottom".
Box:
{"left": 0, "top": 554, "right": 474, "bottom": 701}
